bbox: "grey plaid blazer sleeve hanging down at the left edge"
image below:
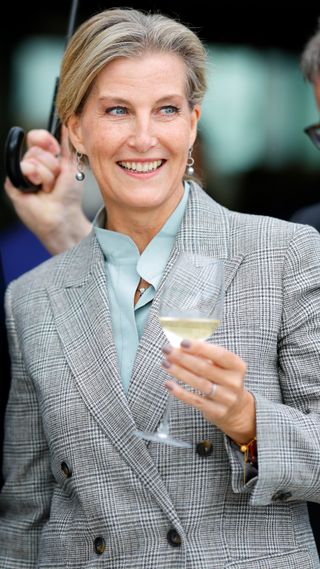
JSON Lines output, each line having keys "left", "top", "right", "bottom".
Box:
{"left": 0, "top": 285, "right": 53, "bottom": 569}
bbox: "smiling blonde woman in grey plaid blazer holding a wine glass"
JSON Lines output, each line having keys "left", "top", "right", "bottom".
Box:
{"left": 0, "top": 9, "right": 320, "bottom": 569}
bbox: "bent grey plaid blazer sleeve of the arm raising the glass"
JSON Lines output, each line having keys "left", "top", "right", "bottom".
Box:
{"left": 225, "top": 225, "right": 320, "bottom": 506}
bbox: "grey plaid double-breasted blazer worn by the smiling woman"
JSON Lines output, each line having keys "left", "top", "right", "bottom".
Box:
{"left": 0, "top": 185, "right": 320, "bottom": 569}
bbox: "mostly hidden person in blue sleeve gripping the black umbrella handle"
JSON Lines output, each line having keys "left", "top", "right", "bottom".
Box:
{"left": 0, "top": 130, "right": 91, "bottom": 486}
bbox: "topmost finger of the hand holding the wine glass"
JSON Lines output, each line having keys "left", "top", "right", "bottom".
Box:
{"left": 180, "top": 340, "right": 246, "bottom": 373}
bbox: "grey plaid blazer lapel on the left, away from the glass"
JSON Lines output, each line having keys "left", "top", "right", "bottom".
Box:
{"left": 48, "top": 235, "right": 183, "bottom": 531}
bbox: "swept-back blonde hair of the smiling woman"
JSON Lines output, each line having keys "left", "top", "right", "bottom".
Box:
{"left": 56, "top": 8, "right": 206, "bottom": 124}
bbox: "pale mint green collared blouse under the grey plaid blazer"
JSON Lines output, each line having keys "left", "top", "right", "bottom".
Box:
{"left": 93, "top": 183, "right": 189, "bottom": 393}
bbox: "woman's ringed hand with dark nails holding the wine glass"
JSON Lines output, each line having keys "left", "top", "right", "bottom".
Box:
{"left": 162, "top": 340, "right": 256, "bottom": 444}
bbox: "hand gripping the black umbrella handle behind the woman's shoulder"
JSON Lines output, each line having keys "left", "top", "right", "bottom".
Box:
{"left": 5, "top": 128, "right": 91, "bottom": 254}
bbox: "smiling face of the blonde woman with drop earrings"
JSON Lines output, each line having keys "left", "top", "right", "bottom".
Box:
{"left": 68, "top": 53, "right": 200, "bottom": 215}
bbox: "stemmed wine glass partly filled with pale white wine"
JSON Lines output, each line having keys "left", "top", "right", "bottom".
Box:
{"left": 135, "top": 253, "right": 224, "bottom": 448}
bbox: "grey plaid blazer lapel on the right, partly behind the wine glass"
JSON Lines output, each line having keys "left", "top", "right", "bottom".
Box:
{"left": 128, "top": 185, "right": 243, "bottom": 431}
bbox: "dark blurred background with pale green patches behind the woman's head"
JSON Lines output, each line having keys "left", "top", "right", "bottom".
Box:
{"left": 0, "top": 0, "right": 320, "bottom": 276}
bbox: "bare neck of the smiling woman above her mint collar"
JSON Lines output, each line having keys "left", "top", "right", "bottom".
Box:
{"left": 106, "top": 189, "right": 183, "bottom": 254}
